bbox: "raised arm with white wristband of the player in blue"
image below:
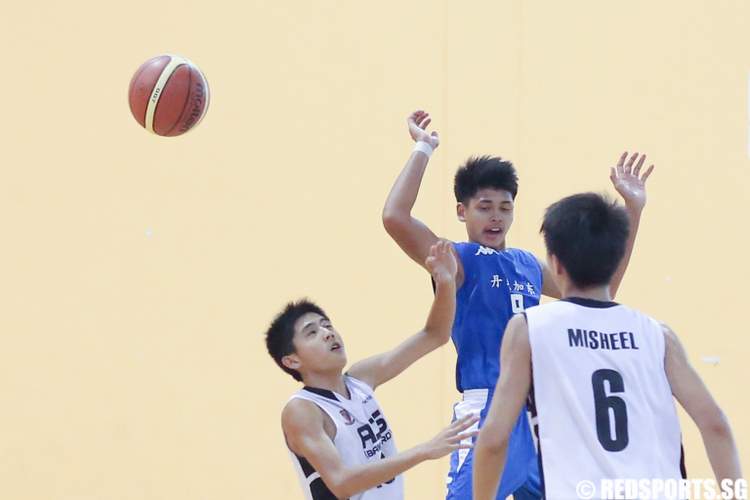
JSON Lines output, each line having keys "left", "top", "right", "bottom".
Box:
{"left": 383, "top": 110, "right": 462, "bottom": 283}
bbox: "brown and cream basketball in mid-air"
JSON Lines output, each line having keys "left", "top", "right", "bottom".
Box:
{"left": 128, "top": 54, "right": 209, "bottom": 137}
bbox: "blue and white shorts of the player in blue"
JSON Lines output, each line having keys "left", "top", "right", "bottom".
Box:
{"left": 446, "top": 389, "right": 542, "bottom": 500}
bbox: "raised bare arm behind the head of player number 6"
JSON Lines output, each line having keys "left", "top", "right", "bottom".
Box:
{"left": 609, "top": 151, "right": 654, "bottom": 298}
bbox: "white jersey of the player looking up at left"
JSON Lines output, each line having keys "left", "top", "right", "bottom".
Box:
{"left": 290, "top": 376, "right": 404, "bottom": 500}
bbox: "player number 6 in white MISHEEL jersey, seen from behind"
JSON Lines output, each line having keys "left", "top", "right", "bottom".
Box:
{"left": 473, "top": 193, "right": 742, "bottom": 500}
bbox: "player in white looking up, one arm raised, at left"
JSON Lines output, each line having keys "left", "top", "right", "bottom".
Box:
{"left": 266, "top": 241, "right": 477, "bottom": 500}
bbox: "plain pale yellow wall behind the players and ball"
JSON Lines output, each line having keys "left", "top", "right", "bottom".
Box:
{"left": 0, "top": 0, "right": 750, "bottom": 500}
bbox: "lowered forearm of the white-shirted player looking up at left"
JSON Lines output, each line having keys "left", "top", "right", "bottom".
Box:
{"left": 331, "top": 446, "right": 427, "bottom": 498}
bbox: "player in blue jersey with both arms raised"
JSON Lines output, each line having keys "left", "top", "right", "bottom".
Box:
{"left": 383, "top": 111, "right": 653, "bottom": 500}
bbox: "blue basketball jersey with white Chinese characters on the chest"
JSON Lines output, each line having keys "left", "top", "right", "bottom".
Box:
{"left": 452, "top": 243, "right": 542, "bottom": 392}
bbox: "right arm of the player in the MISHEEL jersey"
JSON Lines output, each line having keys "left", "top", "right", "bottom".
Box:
{"left": 662, "top": 326, "right": 742, "bottom": 483}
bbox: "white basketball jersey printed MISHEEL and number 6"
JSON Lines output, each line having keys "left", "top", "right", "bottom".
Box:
{"left": 526, "top": 298, "right": 684, "bottom": 499}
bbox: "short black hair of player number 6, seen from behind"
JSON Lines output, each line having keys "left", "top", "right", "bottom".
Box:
{"left": 541, "top": 193, "right": 630, "bottom": 288}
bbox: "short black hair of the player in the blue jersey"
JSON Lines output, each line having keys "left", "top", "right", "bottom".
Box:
{"left": 453, "top": 156, "right": 518, "bottom": 203}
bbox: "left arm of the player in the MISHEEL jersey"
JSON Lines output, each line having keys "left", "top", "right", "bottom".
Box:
{"left": 473, "top": 314, "right": 531, "bottom": 500}
